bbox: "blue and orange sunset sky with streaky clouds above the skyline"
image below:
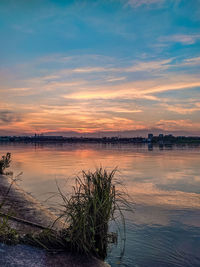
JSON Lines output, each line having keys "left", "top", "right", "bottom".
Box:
{"left": 0, "top": 0, "right": 200, "bottom": 136}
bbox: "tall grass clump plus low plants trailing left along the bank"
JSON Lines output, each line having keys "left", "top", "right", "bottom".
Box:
{"left": 0, "top": 155, "right": 132, "bottom": 259}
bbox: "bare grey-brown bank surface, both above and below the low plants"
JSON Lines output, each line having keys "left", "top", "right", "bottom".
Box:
{"left": 0, "top": 175, "right": 108, "bottom": 267}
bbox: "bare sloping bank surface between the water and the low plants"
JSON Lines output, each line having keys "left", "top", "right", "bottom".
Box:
{"left": 0, "top": 175, "right": 63, "bottom": 232}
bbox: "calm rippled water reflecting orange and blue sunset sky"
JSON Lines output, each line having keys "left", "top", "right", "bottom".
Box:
{"left": 0, "top": 144, "right": 200, "bottom": 267}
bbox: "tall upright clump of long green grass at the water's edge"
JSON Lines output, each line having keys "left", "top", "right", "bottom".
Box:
{"left": 54, "top": 168, "right": 129, "bottom": 259}
